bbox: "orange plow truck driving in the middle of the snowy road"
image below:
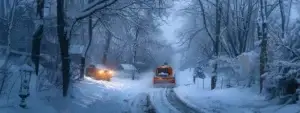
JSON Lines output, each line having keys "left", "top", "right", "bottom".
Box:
{"left": 153, "top": 63, "right": 176, "bottom": 88}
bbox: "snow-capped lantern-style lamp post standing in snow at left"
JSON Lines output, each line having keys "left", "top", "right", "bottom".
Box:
{"left": 19, "top": 64, "right": 34, "bottom": 108}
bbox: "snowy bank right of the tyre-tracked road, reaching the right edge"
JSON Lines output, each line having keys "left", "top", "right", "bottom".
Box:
{"left": 174, "top": 70, "right": 300, "bottom": 113}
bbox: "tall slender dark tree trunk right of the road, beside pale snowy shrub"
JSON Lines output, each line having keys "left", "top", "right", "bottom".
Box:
{"left": 211, "top": 0, "right": 222, "bottom": 90}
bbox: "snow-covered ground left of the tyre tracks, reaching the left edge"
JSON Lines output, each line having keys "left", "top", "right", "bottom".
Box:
{"left": 0, "top": 69, "right": 152, "bottom": 113}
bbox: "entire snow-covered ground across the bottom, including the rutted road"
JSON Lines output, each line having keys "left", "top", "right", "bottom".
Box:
{"left": 0, "top": 66, "right": 300, "bottom": 113}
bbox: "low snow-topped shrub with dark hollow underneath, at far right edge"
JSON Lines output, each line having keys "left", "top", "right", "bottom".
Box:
{"left": 263, "top": 60, "right": 300, "bottom": 104}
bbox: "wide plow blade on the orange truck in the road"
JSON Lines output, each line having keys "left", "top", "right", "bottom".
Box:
{"left": 153, "top": 77, "right": 176, "bottom": 88}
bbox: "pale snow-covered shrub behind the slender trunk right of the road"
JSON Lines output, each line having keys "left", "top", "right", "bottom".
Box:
{"left": 207, "top": 51, "right": 259, "bottom": 87}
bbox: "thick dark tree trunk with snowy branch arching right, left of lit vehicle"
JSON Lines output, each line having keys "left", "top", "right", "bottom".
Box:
{"left": 57, "top": 0, "right": 70, "bottom": 97}
